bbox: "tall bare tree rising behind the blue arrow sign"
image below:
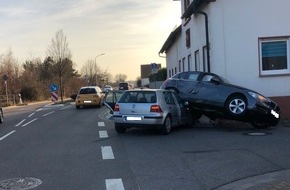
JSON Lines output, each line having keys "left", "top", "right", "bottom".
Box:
{"left": 46, "top": 30, "right": 72, "bottom": 102}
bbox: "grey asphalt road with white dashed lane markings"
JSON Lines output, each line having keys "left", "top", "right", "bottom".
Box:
{"left": 0, "top": 103, "right": 290, "bottom": 190}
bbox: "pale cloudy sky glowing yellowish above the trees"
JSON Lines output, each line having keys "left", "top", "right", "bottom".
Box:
{"left": 0, "top": 0, "right": 181, "bottom": 80}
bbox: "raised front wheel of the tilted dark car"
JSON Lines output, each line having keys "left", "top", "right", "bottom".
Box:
{"left": 226, "top": 95, "right": 247, "bottom": 117}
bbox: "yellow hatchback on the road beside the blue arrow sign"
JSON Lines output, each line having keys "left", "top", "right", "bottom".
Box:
{"left": 75, "top": 86, "right": 105, "bottom": 109}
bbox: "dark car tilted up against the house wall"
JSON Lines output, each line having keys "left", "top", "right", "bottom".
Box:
{"left": 160, "top": 71, "right": 280, "bottom": 128}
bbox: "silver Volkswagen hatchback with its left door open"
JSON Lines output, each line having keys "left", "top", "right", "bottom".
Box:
{"left": 105, "top": 89, "right": 192, "bottom": 134}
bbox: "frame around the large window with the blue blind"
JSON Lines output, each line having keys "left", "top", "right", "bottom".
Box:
{"left": 258, "top": 36, "right": 290, "bottom": 76}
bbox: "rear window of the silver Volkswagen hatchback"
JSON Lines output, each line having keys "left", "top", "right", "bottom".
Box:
{"left": 119, "top": 91, "right": 156, "bottom": 103}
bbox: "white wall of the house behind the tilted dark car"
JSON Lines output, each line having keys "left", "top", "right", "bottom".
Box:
{"left": 166, "top": 0, "right": 290, "bottom": 96}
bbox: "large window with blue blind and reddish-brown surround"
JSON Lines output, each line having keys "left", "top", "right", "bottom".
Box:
{"left": 259, "top": 38, "right": 290, "bottom": 75}
